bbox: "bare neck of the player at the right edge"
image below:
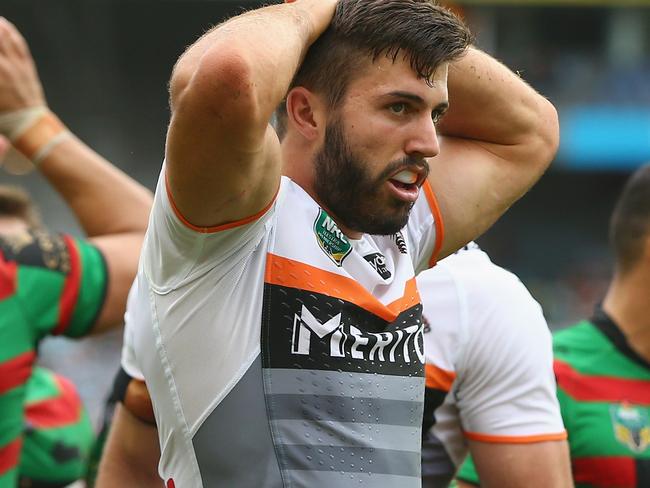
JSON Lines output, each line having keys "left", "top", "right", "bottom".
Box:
{"left": 603, "top": 266, "right": 650, "bottom": 361}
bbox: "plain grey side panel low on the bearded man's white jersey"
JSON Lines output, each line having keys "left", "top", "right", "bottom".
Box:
{"left": 192, "top": 356, "right": 282, "bottom": 488}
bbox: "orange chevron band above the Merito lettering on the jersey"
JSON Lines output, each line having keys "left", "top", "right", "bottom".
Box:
{"left": 264, "top": 253, "right": 420, "bottom": 322}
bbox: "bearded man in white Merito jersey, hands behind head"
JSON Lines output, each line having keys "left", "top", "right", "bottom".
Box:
{"left": 100, "top": 0, "right": 558, "bottom": 487}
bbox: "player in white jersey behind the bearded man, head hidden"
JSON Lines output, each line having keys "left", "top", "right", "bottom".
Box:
{"left": 417, "top": 243, "right": 572, "bottom": 488}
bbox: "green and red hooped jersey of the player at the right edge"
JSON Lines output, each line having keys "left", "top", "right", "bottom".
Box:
{"left": 457, "top": 310, "right": 650, "bottom": 488}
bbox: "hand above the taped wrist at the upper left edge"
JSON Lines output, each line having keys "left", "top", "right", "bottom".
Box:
{"left": 0, "top": 17, "right": 45, "bottom": 113}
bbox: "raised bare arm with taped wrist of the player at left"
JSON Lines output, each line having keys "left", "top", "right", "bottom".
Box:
{"left": 0, "top": 18, "right": 152, "bottom": 332}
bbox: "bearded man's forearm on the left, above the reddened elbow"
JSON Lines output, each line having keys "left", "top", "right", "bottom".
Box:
{"left": 170, "top": 0, "right": 336, "bottom": 118}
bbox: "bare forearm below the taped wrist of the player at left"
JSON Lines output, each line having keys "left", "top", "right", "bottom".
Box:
{"left": 39, "top": 121, "right": 152, "bottom": 237}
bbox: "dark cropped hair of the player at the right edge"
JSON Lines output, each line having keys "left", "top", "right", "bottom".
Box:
{"left": 609, "top": 164, "right": 650, "bottom": 273}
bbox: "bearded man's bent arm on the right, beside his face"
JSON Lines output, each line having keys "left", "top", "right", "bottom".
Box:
{"left": 429, "top": 48, "right": 559, "bottom": 256}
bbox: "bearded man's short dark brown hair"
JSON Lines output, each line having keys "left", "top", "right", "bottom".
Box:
{"left": 275, "top": 0, "right": 472, "bottom": 137}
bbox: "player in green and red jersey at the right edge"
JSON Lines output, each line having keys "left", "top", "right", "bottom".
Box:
{"left": 458, "top": 165, "right": 650, "bottom": 488}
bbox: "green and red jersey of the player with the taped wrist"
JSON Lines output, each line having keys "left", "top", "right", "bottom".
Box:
{"left": 0, "top": 231, "right": 107, "bottom": 488}
